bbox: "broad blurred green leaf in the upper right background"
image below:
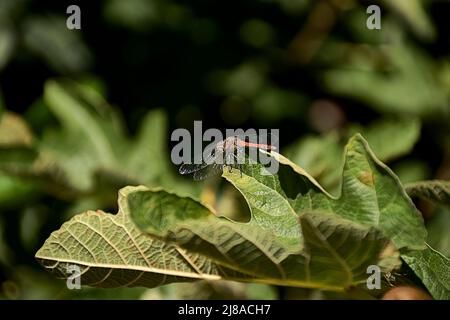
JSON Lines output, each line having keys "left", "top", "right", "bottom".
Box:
{"left": 324, "top": 43, "right": 448, "bottom": 119}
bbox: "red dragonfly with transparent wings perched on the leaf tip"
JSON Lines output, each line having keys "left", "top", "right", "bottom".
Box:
{"left": 179, "top": 135, "right": 276, "bottom": 180}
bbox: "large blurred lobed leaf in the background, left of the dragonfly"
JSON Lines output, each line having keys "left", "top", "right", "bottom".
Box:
{"left": 0, "top": 80, "right": 199, "bottom": 204}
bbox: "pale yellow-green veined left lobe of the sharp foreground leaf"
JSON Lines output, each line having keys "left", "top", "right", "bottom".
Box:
{"left": 36, "top": 187, "right": 251, "bottom": 287}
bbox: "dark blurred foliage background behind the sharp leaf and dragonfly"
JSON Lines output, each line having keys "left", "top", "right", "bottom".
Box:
{"left": 0, "top": 0, "right": 450, "bottom": 299}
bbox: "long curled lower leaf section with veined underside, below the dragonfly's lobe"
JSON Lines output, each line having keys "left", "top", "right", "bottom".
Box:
{"left": 36, "top": 182, "right": 387, "bottom": 290}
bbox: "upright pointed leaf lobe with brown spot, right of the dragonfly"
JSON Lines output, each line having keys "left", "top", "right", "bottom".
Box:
{"left": 258, "top": 134, "right": 427, "bottom": 249}
